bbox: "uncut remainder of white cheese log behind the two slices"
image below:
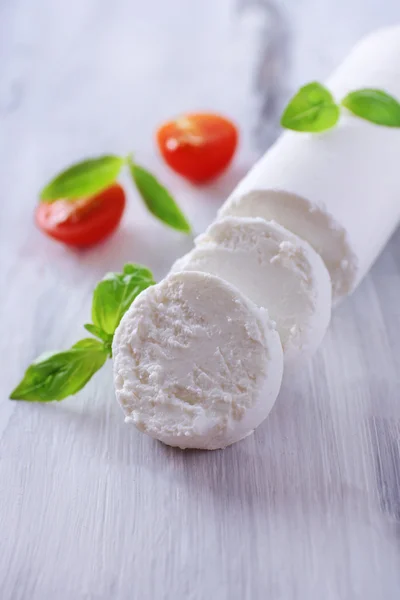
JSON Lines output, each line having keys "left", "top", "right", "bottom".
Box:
{"left": 219, "top": 27, "right": 400, "bottom": 299}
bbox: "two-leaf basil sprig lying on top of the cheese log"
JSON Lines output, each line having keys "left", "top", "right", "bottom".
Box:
{"left": 281, "top": 81, "right": 400, "bottom": 133}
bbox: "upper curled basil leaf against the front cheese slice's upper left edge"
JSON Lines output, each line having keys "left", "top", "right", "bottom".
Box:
{"left": 92, "top": 264, "right": 155, "bottom": 336}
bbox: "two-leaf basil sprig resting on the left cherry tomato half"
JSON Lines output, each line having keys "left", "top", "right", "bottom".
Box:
{"left": 40, "top": 155, "right": 191, "bottom": 233}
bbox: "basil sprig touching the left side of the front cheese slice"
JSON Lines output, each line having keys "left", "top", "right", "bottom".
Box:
{"left": 10, "top": 264, "right": 155, "bottom": 402}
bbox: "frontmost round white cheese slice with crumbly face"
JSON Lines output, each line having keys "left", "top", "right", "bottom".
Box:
{"left": 113, "top": 272, "right": 283, "bottom": 450}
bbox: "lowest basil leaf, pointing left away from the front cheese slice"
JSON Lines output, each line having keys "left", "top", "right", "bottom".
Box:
{"left": 10, "top": 339, "right": 108, "bottom": 402}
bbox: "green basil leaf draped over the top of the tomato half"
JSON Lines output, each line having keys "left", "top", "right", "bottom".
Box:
{"left": 40, "top": 155, "right": 125, "bottom": 202}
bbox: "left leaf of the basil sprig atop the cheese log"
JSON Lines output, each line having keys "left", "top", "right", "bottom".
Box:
{"left": 281, "top": 81, "right": 340, "bottom": 133}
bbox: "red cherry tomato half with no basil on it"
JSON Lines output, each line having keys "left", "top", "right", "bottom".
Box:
{"left": 157, "top": 113, "right": 238, "bottom": 183}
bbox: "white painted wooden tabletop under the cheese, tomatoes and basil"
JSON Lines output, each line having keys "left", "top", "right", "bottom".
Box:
{"left": 0, "top": 0, "right": 400, "bottom": 600}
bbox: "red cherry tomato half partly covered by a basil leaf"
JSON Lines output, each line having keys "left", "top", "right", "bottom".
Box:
{"left": 35, "top": 183, "right": 125, "bottom": 248}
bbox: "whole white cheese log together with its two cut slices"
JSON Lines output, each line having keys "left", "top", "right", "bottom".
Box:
{"left": 113, "top": 27, "right": 400, "bottom": 449}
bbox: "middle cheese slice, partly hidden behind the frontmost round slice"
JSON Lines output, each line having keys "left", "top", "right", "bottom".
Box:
{"left": 172, "top": 217, "right": 332, "bottom": 366}
